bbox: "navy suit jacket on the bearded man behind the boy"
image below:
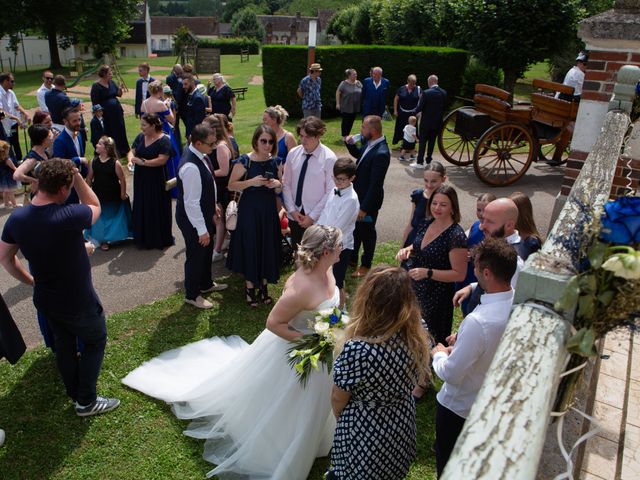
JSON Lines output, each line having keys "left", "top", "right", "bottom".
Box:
{"left": 346, "top": 139, "right": 391, "bottom": 215}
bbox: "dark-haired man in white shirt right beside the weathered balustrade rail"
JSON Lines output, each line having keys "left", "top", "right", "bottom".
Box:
{"left": 431, "top": 238, "right": 517, "bottom": 476}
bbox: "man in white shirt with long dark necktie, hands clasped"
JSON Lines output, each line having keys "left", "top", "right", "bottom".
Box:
{"left": 282, "top": 116, "right": 336, "bottom": 250}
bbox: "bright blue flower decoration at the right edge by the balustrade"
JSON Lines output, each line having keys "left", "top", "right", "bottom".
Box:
{"left": 600, "top": 197, "right": 640, "bottom": 245}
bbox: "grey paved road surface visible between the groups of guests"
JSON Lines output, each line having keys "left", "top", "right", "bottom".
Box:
{"left": 0, "top": 152, "right": 563, "bottom": 347}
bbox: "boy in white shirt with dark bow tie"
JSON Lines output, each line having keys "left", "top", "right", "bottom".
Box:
{"left": 317, "top": 157, "right": 360, "bottom": 306}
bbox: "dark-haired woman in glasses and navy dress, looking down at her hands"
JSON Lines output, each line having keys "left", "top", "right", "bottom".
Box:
{"left": 227, "top": 125, "right": 282, "bottom": 308}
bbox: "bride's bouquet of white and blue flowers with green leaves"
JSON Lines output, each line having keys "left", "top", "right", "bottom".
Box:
{"left": 287, "top": 308, "right": 349, "bottom": 387}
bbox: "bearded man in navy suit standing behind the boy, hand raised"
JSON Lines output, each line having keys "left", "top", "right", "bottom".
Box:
{"left": 345, "top": 115, "right": 391, "bottom": 277}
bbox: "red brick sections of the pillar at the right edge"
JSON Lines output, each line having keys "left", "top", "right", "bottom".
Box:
{"left": 560, "top": 50, "right": 640, "bottom": 201}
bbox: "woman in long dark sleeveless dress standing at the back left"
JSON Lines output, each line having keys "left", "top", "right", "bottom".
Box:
{"left": 91, "top": 65, "right": 129, "bottom": 157}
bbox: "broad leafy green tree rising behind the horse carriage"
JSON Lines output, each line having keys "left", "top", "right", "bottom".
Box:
{"left": 442, "top": 0, "right": 579, "bottom": 92}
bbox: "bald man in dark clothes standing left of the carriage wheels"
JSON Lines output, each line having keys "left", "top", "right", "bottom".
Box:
{"left": 410, "top": 75, "right": 447, "bottom": 168}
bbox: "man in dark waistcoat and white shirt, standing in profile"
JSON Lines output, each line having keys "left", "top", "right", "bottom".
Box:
{"left": 176, "top": 124, "right": 227, "bottom": 309}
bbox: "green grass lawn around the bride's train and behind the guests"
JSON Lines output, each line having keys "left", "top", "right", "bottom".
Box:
{"left": 0, "top": 55, "right": 470, "bottom": 480}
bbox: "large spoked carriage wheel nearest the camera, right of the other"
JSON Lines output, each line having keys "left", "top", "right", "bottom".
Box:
{"left": 473, "top": 123, "right": 536, "bottom": 187}
